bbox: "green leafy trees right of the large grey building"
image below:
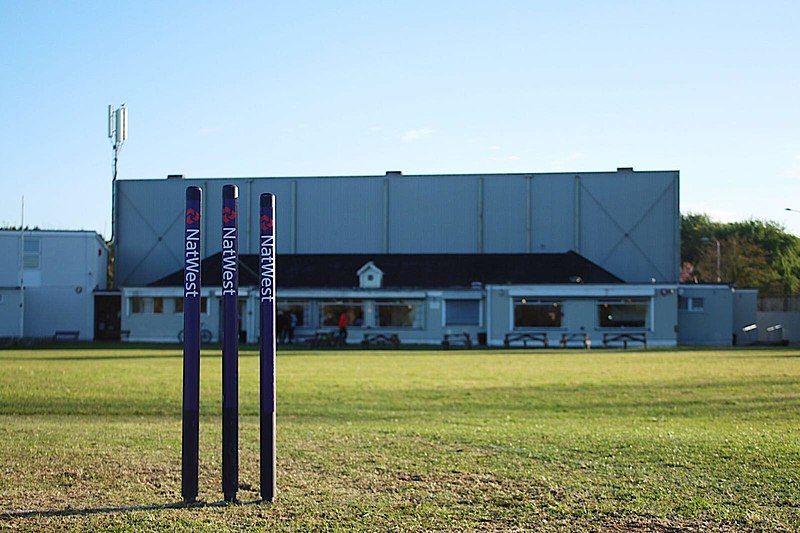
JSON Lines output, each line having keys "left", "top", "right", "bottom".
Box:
{"left": 681, "top": 213, "right": 800, "bottom": 296}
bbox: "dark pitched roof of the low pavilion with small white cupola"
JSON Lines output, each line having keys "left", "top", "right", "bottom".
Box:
{"left": 150, "top": 251, "right": 623, "bottom": 288}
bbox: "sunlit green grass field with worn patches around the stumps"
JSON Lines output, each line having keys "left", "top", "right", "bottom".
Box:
{"left": 0, "top": 346, "right": 800, "bottom": 531}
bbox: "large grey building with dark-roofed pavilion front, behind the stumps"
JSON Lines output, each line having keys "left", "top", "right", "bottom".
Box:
{"left": 115, "top": 168, "right": 751, "bottom": 346}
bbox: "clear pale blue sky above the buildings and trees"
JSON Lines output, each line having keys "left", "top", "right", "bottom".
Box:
{"left": 0, "top": 0, "right": 800, "bottom": 235}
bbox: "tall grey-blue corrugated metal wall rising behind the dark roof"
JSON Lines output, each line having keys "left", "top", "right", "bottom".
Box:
{"left": 116, "top": 170, "right": 680, "bottom": 286}
